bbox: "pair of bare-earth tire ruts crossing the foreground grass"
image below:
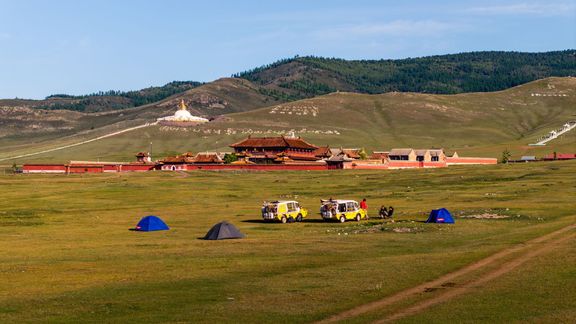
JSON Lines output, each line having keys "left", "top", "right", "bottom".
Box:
{"left": 319, "top": 224, "right": 576, "bottom": 323}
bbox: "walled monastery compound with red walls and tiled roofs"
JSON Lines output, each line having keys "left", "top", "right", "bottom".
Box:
{"left": 23, "top": 135, "right": 497, "bottom": 173}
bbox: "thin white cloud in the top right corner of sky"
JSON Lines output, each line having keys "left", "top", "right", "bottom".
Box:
{"left": 465, "top": 2, "right": 576, "bottom": 16}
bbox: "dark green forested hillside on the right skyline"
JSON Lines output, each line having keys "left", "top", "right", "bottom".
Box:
{"left": 235, "top": 50, "right": 576, "bottom": 99}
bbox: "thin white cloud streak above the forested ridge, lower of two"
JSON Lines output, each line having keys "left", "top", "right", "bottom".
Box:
{"left": 313, "top": 20, "right": 466, "bottom": 38}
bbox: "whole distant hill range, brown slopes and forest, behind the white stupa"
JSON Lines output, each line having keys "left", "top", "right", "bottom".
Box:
{"left": 0, "top": 50, "right": 576, "bottom": 150}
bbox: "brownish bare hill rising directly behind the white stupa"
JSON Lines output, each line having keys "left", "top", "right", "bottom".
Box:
{"left": 0, "top": 78, "right": 277, "bottom": 143}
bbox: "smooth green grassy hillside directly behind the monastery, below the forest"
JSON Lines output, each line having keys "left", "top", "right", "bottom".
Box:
{"left": 0, "top": 78, "right": 576, "bottom": 162}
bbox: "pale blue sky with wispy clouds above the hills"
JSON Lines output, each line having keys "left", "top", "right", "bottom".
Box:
{"left": 0, "top": 0, "right": 576, "bottom": 98}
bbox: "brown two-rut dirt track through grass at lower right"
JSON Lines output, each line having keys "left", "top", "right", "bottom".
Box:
{"left": 320, "top": 224, "right": 576, "bottom": 323}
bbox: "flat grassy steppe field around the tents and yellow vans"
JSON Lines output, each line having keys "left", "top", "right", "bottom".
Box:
{"left": 0, "top": 162, "right": 576, "bottom": 323}
